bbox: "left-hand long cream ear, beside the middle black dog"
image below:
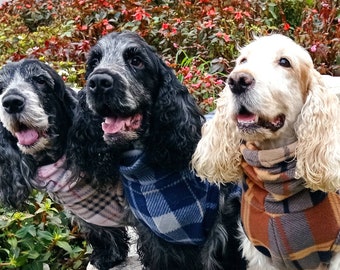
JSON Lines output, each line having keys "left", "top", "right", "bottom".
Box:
{"left": 192, "top": 86, "right": 242, "bottom": 183}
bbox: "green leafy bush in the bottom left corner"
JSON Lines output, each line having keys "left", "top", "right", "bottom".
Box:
{"left": 0, "top": 192, "right": 90, "bottom": 270}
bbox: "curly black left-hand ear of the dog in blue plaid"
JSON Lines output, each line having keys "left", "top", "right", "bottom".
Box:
{"left": 66, "top": 91, "right": 119, "bottom": 188}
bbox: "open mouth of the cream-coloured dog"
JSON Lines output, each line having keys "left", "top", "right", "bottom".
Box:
{"left": 236, "top": 106, "right": 285, "bottom": 132}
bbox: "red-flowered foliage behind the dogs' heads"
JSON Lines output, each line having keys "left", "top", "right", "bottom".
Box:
{"left": 0, "top": 0, "right": 340, "bottom": 109}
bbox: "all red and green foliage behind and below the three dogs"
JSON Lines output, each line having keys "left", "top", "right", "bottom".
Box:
{"left": 0, "top": 0, "right": 340, "bottom": 270}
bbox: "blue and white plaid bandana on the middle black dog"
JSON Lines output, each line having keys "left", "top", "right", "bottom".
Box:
{"left": 120, "top": 150, "right": 219, "bottom": 245}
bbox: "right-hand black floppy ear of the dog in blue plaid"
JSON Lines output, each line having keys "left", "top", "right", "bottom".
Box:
{"left": 146, "top": 60, "right": 204, "bottom": 169}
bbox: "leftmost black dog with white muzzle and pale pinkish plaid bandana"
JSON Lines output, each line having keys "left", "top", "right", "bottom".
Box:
{"left": 0, "top": 59, "right": 129, "bottom": 270}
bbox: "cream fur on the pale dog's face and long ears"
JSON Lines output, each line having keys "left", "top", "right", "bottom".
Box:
{"left": 192, "top": 35, "right": 340, "bottom": 191}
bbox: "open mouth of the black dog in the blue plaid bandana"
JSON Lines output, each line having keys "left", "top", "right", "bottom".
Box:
{"left": 102, "top": 114, "right": 143, "bottom": 135}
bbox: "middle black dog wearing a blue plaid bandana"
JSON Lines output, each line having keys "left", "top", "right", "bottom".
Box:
{"left": 84, "top": 31, "right": 245, "bottom": 270}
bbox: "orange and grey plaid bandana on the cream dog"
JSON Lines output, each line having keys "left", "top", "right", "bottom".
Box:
{"left": 241, "top": 143, "right": 340, "bottom": 269}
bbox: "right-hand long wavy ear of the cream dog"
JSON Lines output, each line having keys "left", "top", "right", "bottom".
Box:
{"left": 295, "top": 70, "right": 340, "bottom": 191}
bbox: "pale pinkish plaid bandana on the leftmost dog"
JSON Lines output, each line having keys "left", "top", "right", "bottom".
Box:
{"left": 34, "top": 157, "right": 125, "bottom": 227}
